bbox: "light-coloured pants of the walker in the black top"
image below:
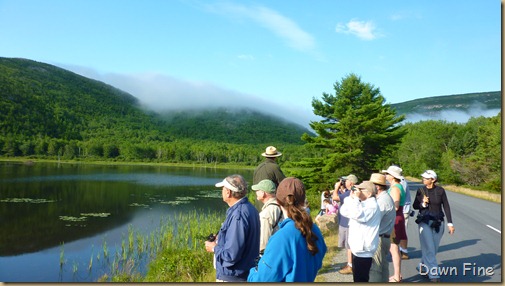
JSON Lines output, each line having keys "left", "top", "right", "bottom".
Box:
{"left": 419, "top": 222, "right": 445, "bottom": 279}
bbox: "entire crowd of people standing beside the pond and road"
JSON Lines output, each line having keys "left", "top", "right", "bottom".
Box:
{"left": 205, "top": 146, "right": 454, "bottom": 282}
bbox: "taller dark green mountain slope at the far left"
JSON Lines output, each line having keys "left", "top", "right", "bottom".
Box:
{"left": 0, "top": 55, "right": 169, "bottom": 140}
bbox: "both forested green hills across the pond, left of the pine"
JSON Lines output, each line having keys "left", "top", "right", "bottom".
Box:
{"left": 0, "top": 57, "right": 308, "bottom": 144}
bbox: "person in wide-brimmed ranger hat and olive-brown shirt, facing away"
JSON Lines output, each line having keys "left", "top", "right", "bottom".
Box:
{"left": 253, "top": 146, "right": 286, "bottom": 187}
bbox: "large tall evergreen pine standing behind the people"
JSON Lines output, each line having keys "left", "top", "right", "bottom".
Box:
{"left": 296, "top": 74, "right": 404, "bottom": 191}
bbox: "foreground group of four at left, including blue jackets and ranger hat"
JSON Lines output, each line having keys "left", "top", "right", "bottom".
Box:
{"left": 205, "top": 146, "right": 326, "bottom": 282}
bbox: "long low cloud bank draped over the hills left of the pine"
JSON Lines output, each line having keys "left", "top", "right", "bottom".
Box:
{"left": 59, "top": 65, "right": 315, "bottom": 128}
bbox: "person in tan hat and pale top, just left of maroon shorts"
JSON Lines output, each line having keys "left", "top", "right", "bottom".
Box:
{"left": 368, "top": 173, "right": 396, "bottom": 283}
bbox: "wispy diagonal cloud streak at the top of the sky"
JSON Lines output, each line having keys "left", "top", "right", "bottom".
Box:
{"left": 206, "top": 3, "right": 316, "bottom": 52}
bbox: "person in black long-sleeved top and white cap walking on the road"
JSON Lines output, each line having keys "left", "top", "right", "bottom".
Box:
{"left": 412, "top": 170, "right": 455, "bottom": 282}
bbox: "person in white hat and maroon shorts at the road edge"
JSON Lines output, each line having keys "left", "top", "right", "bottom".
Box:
{"left": 382, "top": 166, "right": 407, "bottom": 282}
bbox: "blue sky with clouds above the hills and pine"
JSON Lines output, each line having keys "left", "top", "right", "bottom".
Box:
{"left": 0, "top": 0, "right": 501, "bottom": 126}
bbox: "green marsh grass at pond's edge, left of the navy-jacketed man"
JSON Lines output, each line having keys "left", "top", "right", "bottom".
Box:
{"left": 74, "top": 210, "right": 225, "bottom": 282}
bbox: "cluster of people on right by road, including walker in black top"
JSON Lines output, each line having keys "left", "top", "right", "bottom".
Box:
{"left": 332, "top": 165, "right": 454, "bottom": 282}
